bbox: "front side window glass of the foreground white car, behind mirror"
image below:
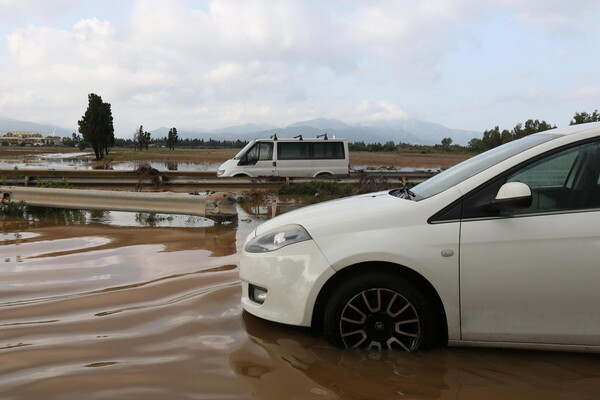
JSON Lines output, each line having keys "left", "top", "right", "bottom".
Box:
{"left": 501, "top": 142, "right": 600, "bottom": 215}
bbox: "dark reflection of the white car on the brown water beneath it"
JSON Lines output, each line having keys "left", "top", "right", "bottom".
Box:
{"left": 237, "top": 313, "right": 600, "bottom": 400}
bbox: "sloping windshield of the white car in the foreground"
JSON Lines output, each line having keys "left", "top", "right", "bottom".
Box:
{"left": 406, "top": 134, "right": 560, "bottom": 200}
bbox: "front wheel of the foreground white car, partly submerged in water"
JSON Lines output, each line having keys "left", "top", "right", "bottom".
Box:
{"left": 324, "top": 272, "right": 435, "bottom": 352}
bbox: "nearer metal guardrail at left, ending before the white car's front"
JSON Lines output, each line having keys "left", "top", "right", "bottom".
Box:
{"left": 0, "top": 186, "right": 237, "bottom": 223}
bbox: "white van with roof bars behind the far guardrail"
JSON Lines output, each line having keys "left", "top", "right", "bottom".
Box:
{"left": 217, "top": 136, "right": 350, "bottom": 177}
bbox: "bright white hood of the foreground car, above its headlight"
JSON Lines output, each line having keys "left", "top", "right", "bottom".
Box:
{"left": 256, "top": 191, "right": 417, "bottom": 235}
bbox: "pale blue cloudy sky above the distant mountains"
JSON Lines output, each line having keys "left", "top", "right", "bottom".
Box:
{"left": 0, "top": 0, "right": 600, "bottom": 137}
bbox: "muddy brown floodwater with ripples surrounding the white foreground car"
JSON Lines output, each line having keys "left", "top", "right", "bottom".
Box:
{"left": 0, "top": 206, "right": 600, "bottom": 400}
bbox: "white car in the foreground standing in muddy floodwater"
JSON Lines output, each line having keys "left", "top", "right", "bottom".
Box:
{"left": 240, "top": 123, "right": 600, "bottom": 351}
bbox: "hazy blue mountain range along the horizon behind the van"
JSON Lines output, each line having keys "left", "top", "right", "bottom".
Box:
{"left": 0, "top": 118, "right": 482, "bottom": 145}
